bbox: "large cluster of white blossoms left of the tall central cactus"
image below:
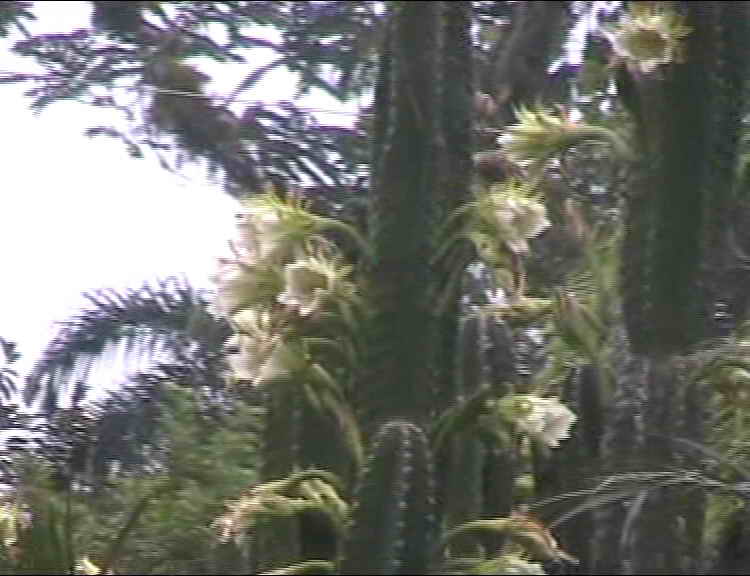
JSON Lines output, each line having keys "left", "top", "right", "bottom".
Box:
{"left": 214, "top": 195, "right": 354, "bottom": 384}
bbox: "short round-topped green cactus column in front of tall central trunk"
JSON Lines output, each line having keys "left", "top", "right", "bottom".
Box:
{"left": 342, "top": 420, "right": 436, "bottom": 574}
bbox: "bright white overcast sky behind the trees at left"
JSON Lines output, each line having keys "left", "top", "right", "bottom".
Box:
{"left": 0, "top": 2, "right": 364, "bottom": 394}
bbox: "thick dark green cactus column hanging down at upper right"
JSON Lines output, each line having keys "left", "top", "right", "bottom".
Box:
{"left": 620, "top": 2, "right": 748, "bottom": 354}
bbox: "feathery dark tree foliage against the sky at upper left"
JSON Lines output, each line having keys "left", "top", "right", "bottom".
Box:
{"left": 0, "top": 2, "right": 382, "bottom": 202}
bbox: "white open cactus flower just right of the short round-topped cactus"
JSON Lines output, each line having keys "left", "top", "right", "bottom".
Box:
{"left": 515, "top": 395, "right": 578, "bottom": 448}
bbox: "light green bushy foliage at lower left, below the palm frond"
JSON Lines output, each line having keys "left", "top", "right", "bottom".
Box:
{"left": 4, "top": 380, "right": 258, "bottom": 574}
